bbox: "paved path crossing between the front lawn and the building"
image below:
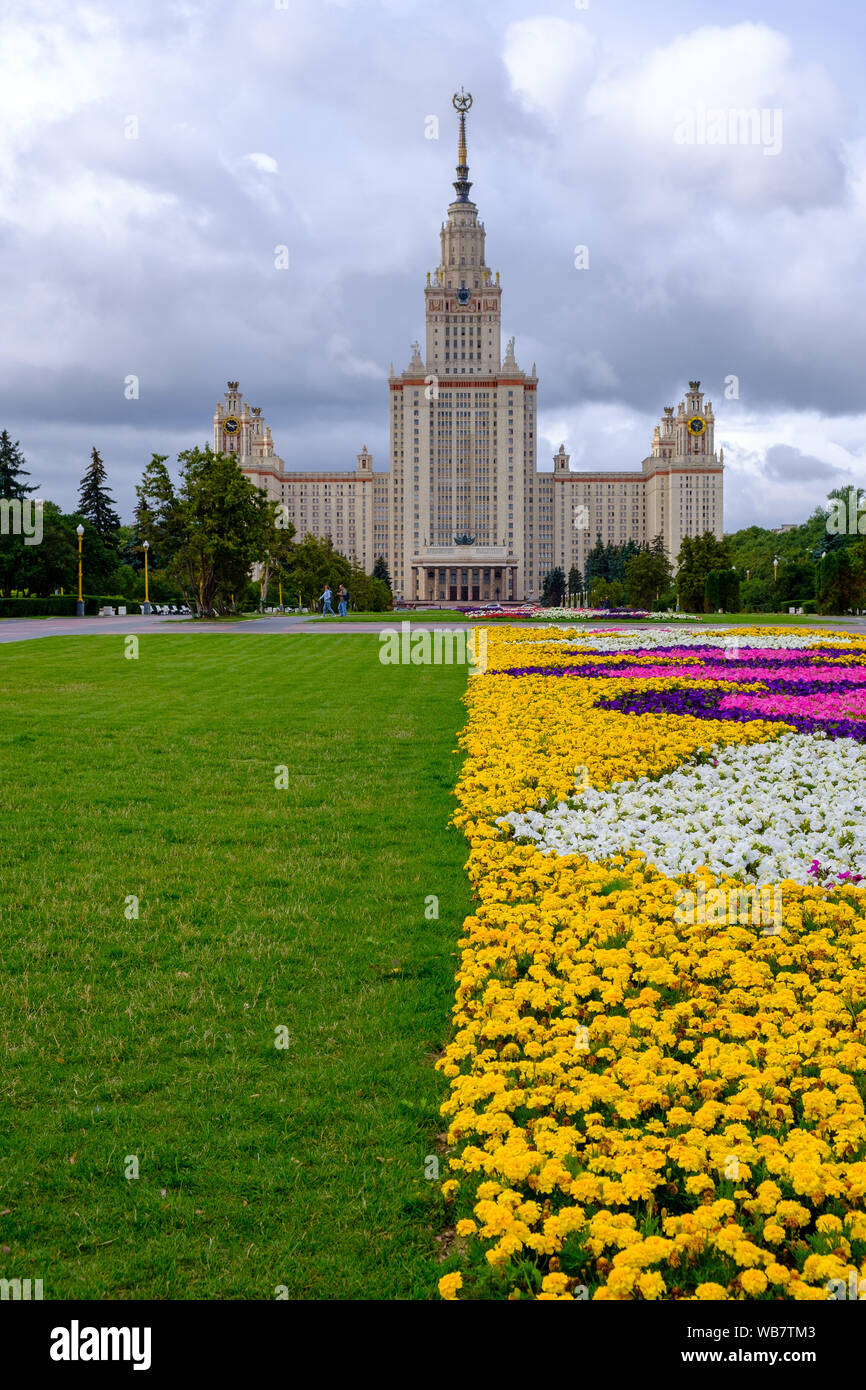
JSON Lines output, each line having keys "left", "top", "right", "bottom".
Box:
{"left": 0, "top": 613, "right": 866, "bottom": 642}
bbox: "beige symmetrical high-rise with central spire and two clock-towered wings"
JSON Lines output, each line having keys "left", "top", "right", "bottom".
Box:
{"left": 214, "top": 92, "right": 724, "bottom": 602}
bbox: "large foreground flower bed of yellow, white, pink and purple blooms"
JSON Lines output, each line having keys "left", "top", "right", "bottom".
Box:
{"left": 438, "top": 630, "right": 866, "bottom": 1301}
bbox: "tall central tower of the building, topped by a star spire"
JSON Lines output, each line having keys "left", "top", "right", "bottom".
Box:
{"left": 389, "top": 90, "right": 537, "bottom": 602}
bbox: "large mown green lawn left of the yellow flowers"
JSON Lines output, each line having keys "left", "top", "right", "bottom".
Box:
{"left": 0, "top": 632, "right": 471, "bottom": 1300}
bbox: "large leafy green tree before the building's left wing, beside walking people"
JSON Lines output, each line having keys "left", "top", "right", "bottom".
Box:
{"left": 136, "top": 448, "right": 274, "bottom": 617}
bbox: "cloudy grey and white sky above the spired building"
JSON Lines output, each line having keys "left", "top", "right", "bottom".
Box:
{"left": 0, "top": 0, "right": 866, "bottom": 530}
